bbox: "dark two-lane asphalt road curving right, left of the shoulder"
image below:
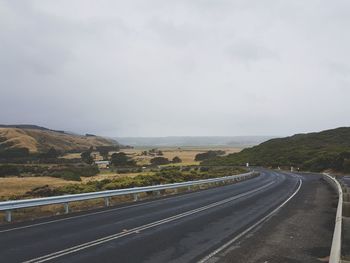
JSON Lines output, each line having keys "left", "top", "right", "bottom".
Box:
{"left": 0, "top": 171, "right": 302, "bottom": 263}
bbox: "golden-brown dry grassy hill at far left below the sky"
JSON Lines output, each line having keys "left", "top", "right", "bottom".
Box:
{"left": 0, "top": 125, "right": 118, "bottom": 153}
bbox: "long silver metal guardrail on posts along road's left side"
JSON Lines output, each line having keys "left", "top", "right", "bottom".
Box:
{"left": 0, "top": 172, "right": 254, "bottom": 222}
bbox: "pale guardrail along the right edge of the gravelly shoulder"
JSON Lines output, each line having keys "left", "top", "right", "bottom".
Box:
{"left": 323, "top": 173, "right": 343, "bottom": 263}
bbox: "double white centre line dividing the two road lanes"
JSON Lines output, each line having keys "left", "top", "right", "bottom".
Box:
{"left": 24, "top": 181, "right": 275, "bottom": 263}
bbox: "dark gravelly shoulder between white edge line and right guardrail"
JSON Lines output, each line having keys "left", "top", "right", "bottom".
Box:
{"left": 210, "top": 174, "right": 337, "bottom": 263}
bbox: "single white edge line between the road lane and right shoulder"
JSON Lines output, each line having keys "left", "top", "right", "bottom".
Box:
{"left": 198, "top": 178, "right": 302, "bottom": 263}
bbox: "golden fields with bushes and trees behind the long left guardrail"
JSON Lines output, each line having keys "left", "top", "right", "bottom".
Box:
{"left": 0, "top": 142, "right": 242, "bottom": 200}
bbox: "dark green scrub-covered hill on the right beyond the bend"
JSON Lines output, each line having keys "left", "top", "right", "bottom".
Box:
{"left": 202, "top": 127, "right": 350, "bottom": 172}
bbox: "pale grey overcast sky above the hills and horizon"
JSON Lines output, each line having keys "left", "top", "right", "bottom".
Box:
{"left": 0, "top": 0, "right": 350, "bottom": 136}
